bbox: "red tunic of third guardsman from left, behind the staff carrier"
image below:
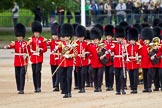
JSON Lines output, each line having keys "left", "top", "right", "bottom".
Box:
{"left": 47, "top": 39, "right": 60, "bottom": 65}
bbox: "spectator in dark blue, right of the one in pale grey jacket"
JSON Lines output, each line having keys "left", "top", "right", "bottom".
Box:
{"left": 126, "top": 0, "right": 133, "bottom": 24}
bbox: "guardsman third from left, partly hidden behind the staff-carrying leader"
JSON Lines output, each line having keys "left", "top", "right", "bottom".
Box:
{"left": 47, "top": 23, "right": 60, "bottom": 91}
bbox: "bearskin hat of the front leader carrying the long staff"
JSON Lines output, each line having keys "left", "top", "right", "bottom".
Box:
{"left": 60, "top": 23, "right": 74, "bottom": 37}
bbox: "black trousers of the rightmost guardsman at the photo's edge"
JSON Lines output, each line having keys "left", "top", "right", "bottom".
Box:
{"left": 153, "top": 68, "right": 160, "bottom": 89}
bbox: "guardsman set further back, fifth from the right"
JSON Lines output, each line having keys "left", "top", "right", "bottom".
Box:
{"left": 104, "top": 25, "right": 115, "bottom": 91}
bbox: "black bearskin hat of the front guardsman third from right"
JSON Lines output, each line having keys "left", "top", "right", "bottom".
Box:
{"left": 128, "top": 28, "right": 138, "bottom": 41}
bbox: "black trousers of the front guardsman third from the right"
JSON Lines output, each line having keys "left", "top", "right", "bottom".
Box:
{"left": 129, "top": 69, "right": 138, "bottom": 90}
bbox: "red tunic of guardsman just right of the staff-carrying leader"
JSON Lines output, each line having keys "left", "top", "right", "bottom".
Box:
{"left": 75, "top": 41, "right": 89, "bottom": 67}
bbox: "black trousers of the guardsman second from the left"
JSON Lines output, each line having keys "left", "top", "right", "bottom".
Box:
{"left": 32, "top": 63, "right": 42, "bottom": 90}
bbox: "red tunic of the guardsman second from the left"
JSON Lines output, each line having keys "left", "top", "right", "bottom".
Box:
{"left": 29, "top": 36, "right": 47, "bottom": 64}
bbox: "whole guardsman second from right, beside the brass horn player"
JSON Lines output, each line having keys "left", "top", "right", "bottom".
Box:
{"left": 139, "top": 27, "right": 154, "bottom": 92}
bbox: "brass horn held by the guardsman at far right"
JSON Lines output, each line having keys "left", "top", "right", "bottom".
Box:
{"left": 148, "top": 37, "right": 160, "bottom": 65}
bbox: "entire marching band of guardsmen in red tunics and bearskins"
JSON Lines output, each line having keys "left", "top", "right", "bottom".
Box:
{"left": 4, "top": 19, "right": 162, "bottom": 98}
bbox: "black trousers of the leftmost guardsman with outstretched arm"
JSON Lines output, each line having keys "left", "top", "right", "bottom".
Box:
{"left": 15, "top": 66, "right": 25, "bottom": 91}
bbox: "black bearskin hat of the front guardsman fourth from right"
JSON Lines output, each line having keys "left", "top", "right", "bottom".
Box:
{"left": 115, "top": 26, "right": 125, "bottom": 38}
